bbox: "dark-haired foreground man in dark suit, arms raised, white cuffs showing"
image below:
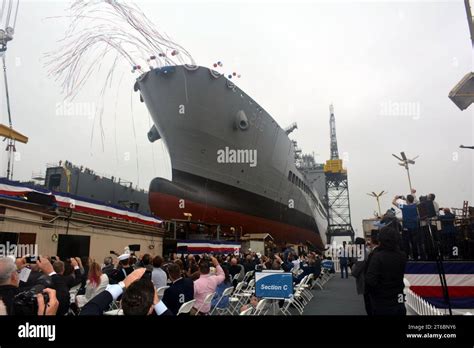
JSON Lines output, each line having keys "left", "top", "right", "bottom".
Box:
{"left": 80, "top": 268, "right": 173, "bottom": 315}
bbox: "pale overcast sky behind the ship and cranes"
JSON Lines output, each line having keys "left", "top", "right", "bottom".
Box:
{"left": 0, "top": 0, "right": 474, "bottom": 237}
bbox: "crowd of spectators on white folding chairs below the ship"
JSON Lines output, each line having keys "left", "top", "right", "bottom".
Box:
{"left": 0, "top": 247, "right": 322, "bottom": 315}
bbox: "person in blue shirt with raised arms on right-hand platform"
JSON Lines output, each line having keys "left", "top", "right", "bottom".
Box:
{"left": 392, "top": 189, "right": 426, "bottom": 260}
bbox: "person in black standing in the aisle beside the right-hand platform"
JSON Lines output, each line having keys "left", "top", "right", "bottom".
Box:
{"left": 365, "top": 220, "right": 407, "bottom": 315}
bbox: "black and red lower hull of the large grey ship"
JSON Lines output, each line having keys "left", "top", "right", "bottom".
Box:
{"left": 149, "top": 170, "right": 323, "bottom": 249}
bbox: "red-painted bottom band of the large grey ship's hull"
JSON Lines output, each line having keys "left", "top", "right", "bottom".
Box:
{"left": 149, "top": 192, "right": 324, "bottom": 249}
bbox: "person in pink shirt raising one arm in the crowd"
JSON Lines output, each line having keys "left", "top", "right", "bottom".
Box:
{"left": 194, "top": 256, "right": 225, "bottom": 315}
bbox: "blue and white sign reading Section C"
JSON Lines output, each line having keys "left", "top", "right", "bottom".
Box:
{"left": 255, "top": 272, "right": 293, "bottom": 299}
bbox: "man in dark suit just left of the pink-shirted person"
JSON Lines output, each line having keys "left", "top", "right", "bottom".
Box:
{"left": 163, "top": 263, "right": 194, "bottom": 314}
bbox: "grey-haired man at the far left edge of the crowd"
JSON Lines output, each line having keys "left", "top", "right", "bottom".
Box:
{"left": 0, "top": 257, "right": 20, "bottom": 315}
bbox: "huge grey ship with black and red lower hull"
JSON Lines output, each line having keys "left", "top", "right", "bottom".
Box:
{"left": 134, "top": 65, "right": 327, "bottom": 249}
